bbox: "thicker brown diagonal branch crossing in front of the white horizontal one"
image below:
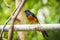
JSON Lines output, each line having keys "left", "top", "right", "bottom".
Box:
{"left": 8, "top": 0, "right": 25, "bottom": 40}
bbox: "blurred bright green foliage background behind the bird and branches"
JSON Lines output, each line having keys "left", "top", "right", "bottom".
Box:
{"left": 0, "top": 0, "right": 60, "bottom": 40}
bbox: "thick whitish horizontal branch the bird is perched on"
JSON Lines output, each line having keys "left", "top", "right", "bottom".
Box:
{"left": 0, "top": 24, "right": 60, "bottom": 31}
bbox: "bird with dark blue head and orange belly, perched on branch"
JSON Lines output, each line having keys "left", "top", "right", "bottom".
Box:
{"left": 24, "top": 10, "right": 48, "bottom": 37}
